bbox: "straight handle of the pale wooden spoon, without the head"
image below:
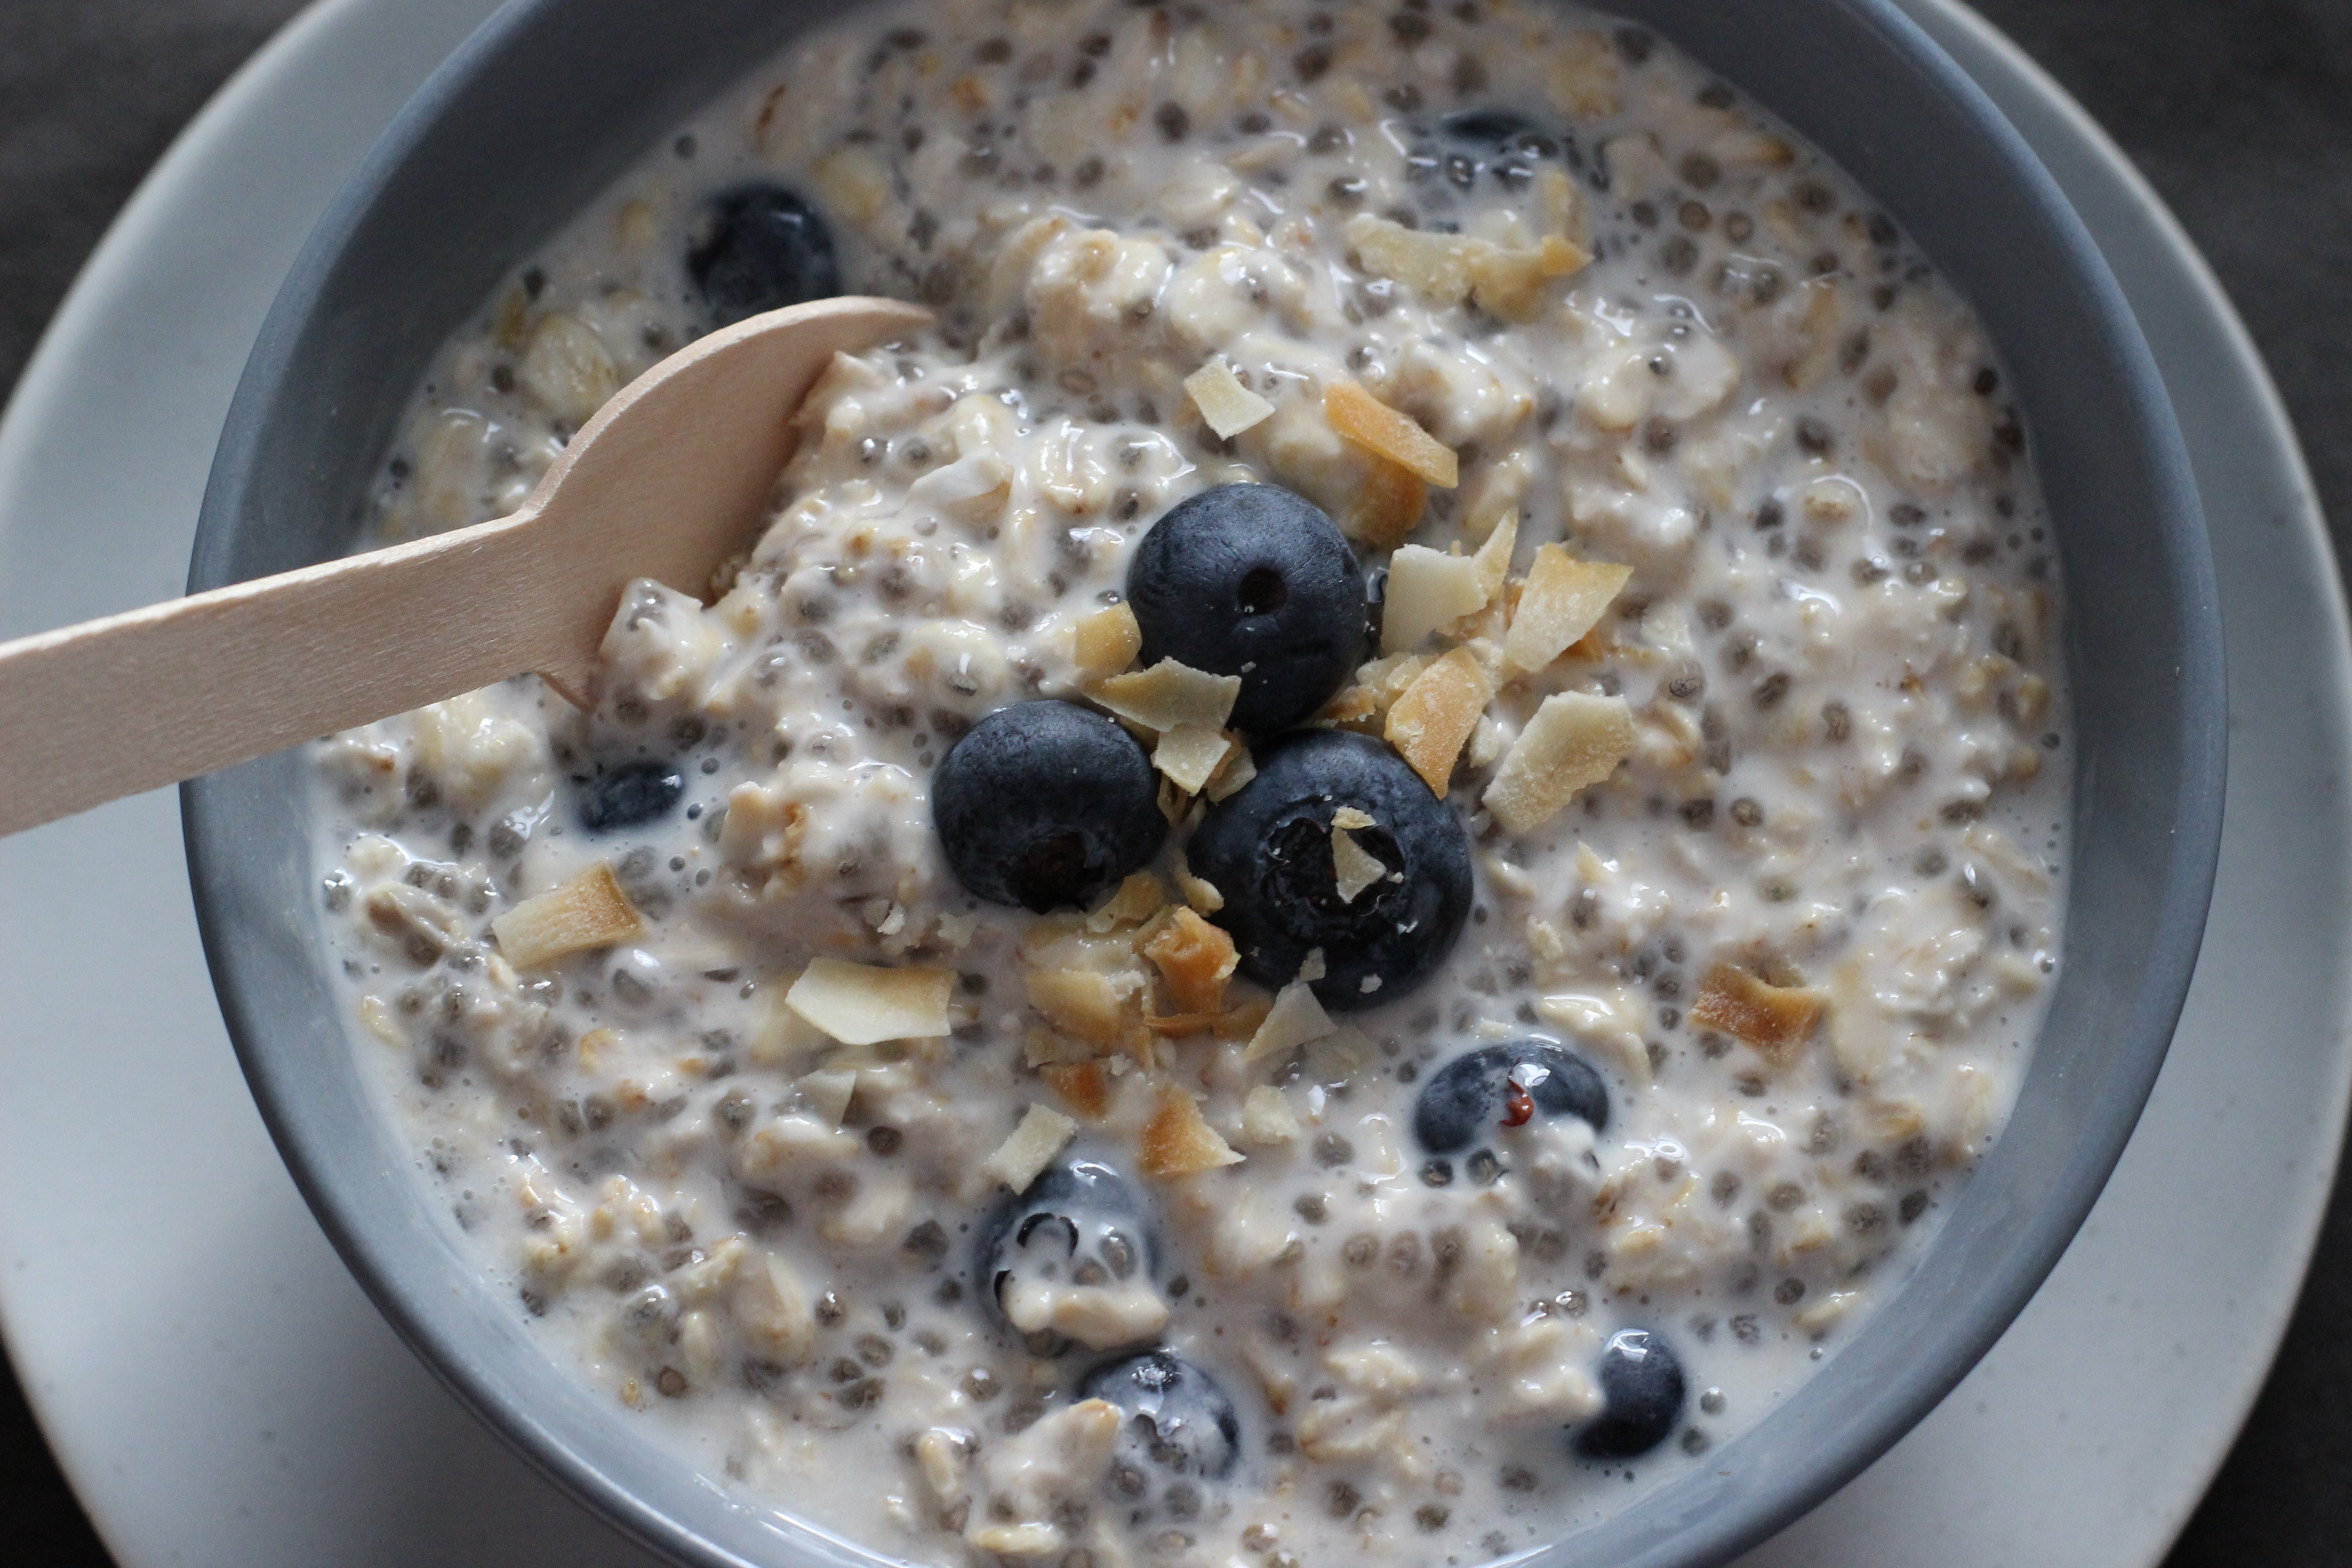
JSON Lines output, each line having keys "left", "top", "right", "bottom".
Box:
{"left": 0, "top": 510, "right": 550, "bottom": 834}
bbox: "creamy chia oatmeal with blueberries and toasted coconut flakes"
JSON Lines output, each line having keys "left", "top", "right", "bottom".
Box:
{"left": 318, "top": 0, "right": 2070, "bottom": 1568}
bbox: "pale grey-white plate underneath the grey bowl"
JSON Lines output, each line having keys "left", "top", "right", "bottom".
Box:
{"left": 0, "top": 0, "right": 2352, "bottom": 1568}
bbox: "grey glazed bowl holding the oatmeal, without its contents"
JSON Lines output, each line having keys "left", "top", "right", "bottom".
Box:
{"left": 183, "top": 0, "right": 2225, "bottom": 1568}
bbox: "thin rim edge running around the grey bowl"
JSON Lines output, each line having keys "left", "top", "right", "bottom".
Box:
{"left": 181, "top": 0, "right": 2227, "bottom": 1568}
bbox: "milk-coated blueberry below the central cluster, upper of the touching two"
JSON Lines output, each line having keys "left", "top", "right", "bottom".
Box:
{"left": 981, "top": 1159, "right": 1157, "bottom": 1349}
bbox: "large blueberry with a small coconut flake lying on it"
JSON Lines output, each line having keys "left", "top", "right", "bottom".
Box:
{"left": 1186, "top": 729, "right": 1470, "bottom": 1009}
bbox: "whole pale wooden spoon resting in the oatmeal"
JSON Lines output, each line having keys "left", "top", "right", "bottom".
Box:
{"left": 0, "top": 299, "right": 931, "bottom": 834}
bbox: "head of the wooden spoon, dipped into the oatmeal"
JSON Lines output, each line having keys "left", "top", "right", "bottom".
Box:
{"left": 513, "top": 296, "right": 931, "bottom": 703}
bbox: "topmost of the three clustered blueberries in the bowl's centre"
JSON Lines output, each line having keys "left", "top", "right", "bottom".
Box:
{"left": 1127, "top": 484, "right": 1364, "bottom": 736}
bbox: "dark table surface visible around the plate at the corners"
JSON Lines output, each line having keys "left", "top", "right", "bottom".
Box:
{"left": 0, "top": 0, "right": 2352, "bottom": 1568}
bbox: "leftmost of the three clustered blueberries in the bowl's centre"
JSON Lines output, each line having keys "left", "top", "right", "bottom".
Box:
{"left": 931, "top": 703, "right": 1169, "bottom": 915}
